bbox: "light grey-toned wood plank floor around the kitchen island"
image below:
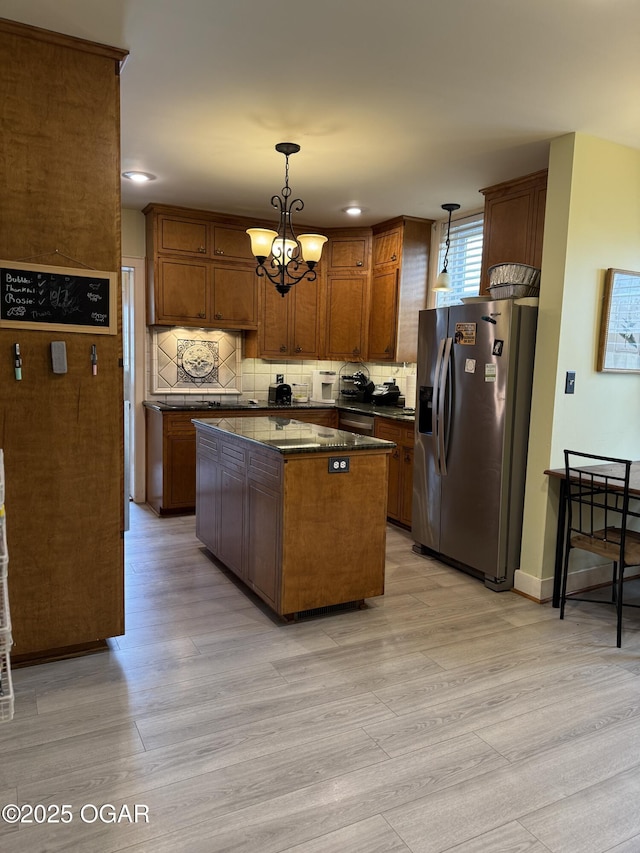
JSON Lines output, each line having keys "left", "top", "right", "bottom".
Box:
{"left": 0, "top": 506, "right": 640, "bottom": 853}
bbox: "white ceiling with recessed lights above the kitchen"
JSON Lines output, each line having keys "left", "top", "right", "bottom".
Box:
{"left": 0, "top": 0, "right": 640, "bottom": 227}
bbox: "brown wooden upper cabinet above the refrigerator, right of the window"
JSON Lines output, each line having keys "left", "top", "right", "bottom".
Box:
{"left": 480, "top": 169, "right": 547, "bottom": 293}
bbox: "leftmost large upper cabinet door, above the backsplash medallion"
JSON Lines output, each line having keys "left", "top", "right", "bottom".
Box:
{"left": 155, "top": 258, "right": 211, "bottom": 326}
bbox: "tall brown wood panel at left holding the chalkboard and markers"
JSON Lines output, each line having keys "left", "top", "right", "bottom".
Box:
{"left": 0, "top": 20, "right": 126, "bottom": 660}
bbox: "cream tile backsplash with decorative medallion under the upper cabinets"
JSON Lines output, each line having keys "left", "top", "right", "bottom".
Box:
{"left": 147, "top": 328, "right": 416, "bottom": 406}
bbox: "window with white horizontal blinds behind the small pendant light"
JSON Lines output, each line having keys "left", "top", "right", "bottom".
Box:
{"left": 436, "top": 213, "right": 484, "bottom": 308}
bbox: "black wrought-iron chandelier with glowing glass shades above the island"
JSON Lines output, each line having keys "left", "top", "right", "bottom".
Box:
{"left": 247, "top": 142, "right": 327, "bottom": 296}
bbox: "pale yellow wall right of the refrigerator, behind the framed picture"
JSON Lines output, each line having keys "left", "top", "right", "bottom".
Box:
{"left": 515, "top": 134, "right": 640, "bottom": 599}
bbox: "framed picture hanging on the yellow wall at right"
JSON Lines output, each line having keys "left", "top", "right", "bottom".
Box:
{"left": 597, "top": 269, "right": 640, "bottom": 373}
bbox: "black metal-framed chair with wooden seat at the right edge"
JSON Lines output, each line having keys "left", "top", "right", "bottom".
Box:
{"left": 560, "top": 450, "right": 640, "bottom": 648}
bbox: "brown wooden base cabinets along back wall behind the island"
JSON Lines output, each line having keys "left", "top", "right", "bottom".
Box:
{"left": 145, "top": 406, "right": 338, "bottom": 516}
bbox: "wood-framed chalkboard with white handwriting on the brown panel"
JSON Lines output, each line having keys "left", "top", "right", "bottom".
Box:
{"left": 0, "top": 261, "right": 118, "bottom": 335}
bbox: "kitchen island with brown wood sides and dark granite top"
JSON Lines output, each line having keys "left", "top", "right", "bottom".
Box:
{"left": 193, "top": 417, "right": 395, "bottom": 619}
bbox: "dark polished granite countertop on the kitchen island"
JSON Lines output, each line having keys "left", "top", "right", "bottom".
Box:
{"left": 193, "top": 418, "right": 396, "bottom": 455}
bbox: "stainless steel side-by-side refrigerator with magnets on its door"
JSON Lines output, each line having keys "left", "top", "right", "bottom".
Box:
{"left": 412, "top": 299, "right": 538, "bottom": 591}
